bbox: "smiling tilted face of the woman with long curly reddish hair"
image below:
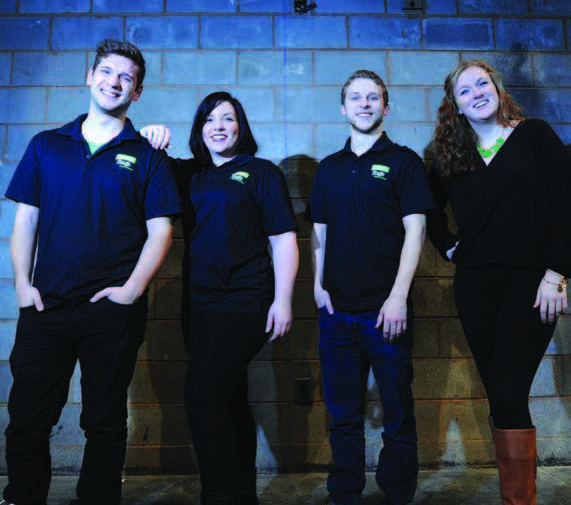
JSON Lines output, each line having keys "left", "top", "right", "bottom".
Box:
{"left": 454, "top": 67, "right": 500, "bottom": 123}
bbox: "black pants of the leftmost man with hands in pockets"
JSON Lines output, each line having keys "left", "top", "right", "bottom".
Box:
{"left": 4, "top": 298, "right": 147, "bottom": 505}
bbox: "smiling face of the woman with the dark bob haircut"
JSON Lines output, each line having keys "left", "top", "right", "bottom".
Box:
{"left": 202, "top": 102, "right": 240, "bottom": 166}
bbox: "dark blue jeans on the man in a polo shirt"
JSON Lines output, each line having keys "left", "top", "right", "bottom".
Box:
{"left": 319, "top": 309, "right": 418, "bottom": 505}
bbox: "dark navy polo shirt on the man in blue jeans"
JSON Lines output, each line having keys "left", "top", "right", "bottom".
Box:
{"left": 306, "top": 133, "right": 434, "bottom": 312}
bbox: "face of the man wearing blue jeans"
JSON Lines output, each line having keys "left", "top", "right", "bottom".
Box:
{"left": 341, "top": 78, "right": 389, "bottom": 134}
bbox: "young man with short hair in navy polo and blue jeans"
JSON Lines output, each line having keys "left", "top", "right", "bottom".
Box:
{"left": 306, "top": 70, "right": 433, "bottom": 505}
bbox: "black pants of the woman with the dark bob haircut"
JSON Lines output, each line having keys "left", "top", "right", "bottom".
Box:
{"left": 185, "top": 312, "right": 268, "bottom": 495}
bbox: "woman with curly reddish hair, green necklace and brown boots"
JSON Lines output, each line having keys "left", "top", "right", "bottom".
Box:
{"left": 428, "top": 60, "right": 571, "bottom": 505}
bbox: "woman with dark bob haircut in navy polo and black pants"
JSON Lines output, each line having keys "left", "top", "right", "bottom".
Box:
{"left": 145, "top": 92, "right": 298, "bottom": 505}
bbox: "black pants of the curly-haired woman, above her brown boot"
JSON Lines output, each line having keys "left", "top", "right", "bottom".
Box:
{"left": 454, "top": 267, "right": 555, "bottom": 429}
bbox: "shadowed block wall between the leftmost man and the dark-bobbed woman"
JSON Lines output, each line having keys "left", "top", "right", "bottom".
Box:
{"left": 126, "top": 240, "right": 198, "bottom": 474}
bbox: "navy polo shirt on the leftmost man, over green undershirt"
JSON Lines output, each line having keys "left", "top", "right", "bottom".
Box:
{"left": 6, "top": 115, "right": 179, "bottom": 308}
